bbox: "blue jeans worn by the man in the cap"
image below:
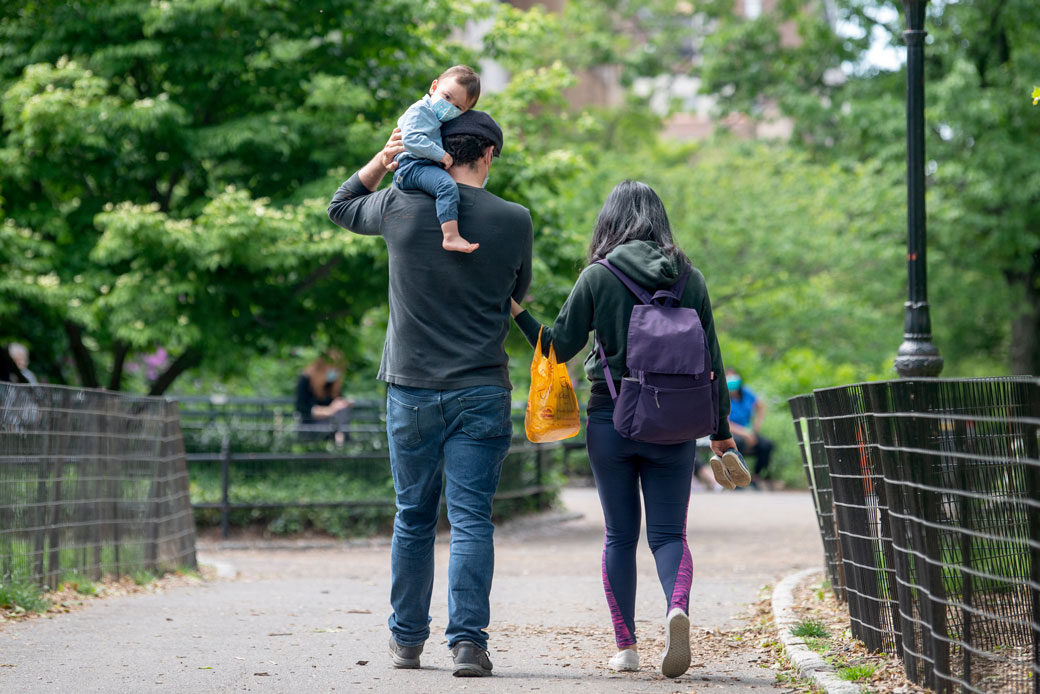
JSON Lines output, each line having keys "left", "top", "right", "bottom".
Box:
{"left": 387, "top": 384, "right": 513, "bottom": 648}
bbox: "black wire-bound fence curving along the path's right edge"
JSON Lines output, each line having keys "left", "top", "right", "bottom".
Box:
{"left": 790, "top": 378, "right": 1040, "bottom": 694}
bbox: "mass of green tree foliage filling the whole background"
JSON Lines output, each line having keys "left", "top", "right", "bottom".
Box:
{"left": 0, "top": 0, "right": 1040, "bottom": 489}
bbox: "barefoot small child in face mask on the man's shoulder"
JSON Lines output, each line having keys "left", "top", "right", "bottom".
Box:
{"left": 393, "top": 66, "right": 480, "bottom": 253}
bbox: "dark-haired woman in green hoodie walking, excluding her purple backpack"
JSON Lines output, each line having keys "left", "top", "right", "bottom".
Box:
{"left": 512, "top": 181, "right": 735, "bottom": 677}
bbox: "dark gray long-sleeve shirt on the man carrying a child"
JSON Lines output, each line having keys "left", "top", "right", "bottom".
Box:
{"left": 329, "top": 174, "right": 532, "bottom": 390}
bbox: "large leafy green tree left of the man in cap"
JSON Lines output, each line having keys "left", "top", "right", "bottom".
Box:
{"left": 0, "top": 0, "right": 474, "bottom": 392}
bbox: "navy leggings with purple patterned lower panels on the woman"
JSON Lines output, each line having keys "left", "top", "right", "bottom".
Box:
{"left": 586, "top": 410, "right": 696, "bottom": 648}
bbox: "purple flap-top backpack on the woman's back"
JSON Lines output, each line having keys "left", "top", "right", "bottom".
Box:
{"left": 596, "top": 260, "right": 719, "bottom": 443}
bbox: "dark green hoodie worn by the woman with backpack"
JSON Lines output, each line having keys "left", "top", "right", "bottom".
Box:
{"left": 516, "top": 241, "right": 730, "bottom": 440}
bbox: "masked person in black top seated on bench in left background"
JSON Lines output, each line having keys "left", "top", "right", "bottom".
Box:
{"left": 296, "top": 354, "right": 354, "bottom": 445}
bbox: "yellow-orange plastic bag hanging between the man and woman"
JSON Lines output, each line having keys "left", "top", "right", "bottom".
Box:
{"left": 523, "top": 331, "right": 581, "bottom": 443}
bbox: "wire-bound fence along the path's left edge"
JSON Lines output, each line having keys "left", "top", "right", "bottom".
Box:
{"left": 0, "top": 383, "right": 196, "bottom": 588}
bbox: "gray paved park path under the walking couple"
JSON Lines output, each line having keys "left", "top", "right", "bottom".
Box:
{"left": 0, "top": 489, "right": 823, "bottom": 694}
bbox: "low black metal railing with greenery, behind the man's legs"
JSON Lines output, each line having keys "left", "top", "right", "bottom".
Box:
{"left": 170, "top": 395, "right": 565, "bottom": 537}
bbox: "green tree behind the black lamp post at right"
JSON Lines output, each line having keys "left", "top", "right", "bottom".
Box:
{"left": 703, "top": 0, "right": 1040, "bottom": 374}
